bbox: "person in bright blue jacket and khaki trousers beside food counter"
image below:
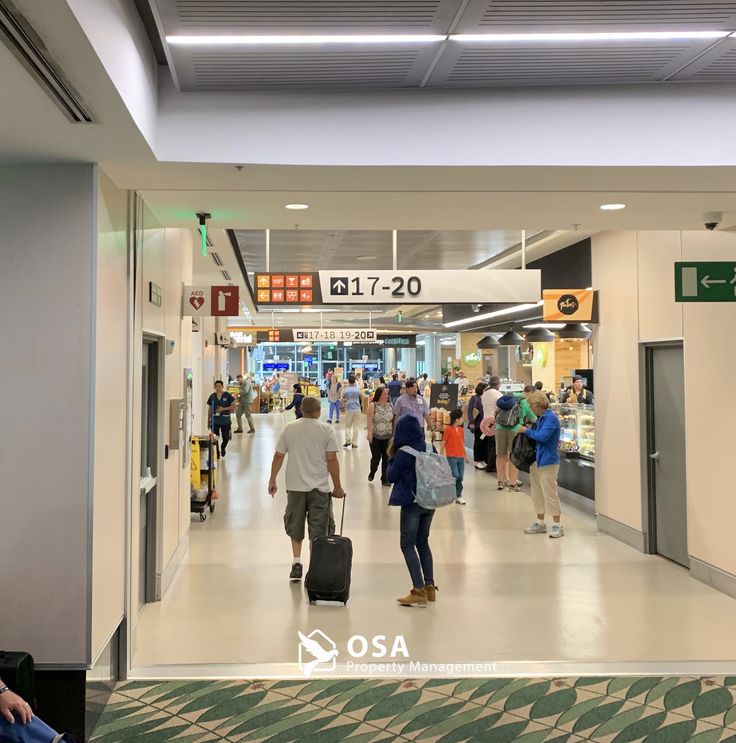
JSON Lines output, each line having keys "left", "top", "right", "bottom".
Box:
{"left": 519, "top": 392, "right": 565, "bottom": 539}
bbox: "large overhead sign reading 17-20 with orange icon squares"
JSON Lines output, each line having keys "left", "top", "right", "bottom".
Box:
{"left": 256, "top": 269, "right": 542, "bottom": 306}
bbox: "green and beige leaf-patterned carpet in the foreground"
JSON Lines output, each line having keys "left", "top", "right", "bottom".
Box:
{"left": 92, "top": 676, "right": 736, "bottom": 743}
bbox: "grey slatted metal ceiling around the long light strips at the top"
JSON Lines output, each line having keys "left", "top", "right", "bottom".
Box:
{"left": 149, "top": 0, "right": 736, "bottom": 91}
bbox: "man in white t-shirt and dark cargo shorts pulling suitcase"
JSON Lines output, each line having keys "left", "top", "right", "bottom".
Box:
{"left": 268, "top": 397, "right": 345, "bottom": 580}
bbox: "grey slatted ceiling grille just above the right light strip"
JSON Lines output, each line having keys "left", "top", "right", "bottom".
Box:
{"left": 480, "top": 0, "right": 736, "bottom": 31}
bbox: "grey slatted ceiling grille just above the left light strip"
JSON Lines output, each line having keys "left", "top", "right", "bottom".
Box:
{"left": 175, "top": 0, "right": 446, "bottom": 29}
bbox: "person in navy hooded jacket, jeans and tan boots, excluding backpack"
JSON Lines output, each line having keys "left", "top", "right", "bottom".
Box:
{"left": 387, "top": 415, "right": 437, "bottom": 607}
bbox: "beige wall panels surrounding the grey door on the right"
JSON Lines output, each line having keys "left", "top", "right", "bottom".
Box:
{"left": 593, "top": 232, "right": 736, "bottom": 574}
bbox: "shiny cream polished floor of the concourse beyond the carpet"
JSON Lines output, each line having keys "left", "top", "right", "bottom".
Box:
{"left": 133, "top": 413, "right": 736, "bottom": 678}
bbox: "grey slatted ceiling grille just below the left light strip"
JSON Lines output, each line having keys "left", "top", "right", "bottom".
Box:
{"left": 193, "top": 49, "right": 417, "bottom": 90}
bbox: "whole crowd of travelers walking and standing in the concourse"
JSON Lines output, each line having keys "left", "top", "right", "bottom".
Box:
{"left": 208, "top": 372, "right": 592, "bottom": 607}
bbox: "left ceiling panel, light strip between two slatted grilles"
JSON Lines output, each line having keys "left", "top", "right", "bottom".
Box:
{"left": 151, "top": 0, "right": 461, "bottom": 91}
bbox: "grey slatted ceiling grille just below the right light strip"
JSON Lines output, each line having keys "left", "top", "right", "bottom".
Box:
{"left": 447, "top": 44, "right": 687, "bottom": 85}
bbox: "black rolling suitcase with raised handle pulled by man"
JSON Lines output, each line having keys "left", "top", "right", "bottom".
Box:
{"left": 304, "top": 498, "right": 353, "bottom": 604}
